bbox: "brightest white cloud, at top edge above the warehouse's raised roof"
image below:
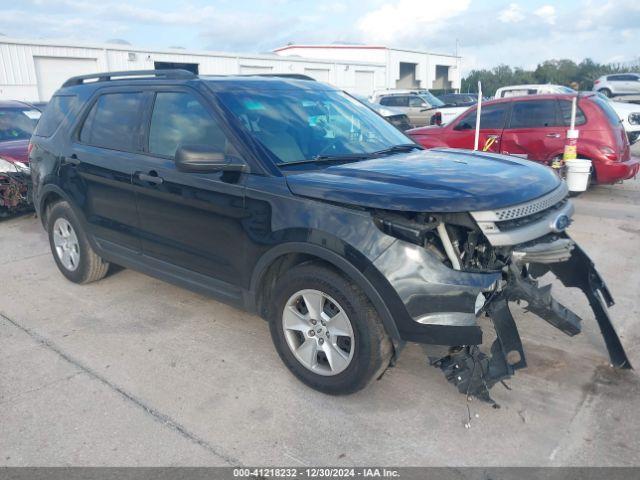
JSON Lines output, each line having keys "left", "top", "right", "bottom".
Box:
{"left": 356, "top": 0, "right": 471, "bottom": 44}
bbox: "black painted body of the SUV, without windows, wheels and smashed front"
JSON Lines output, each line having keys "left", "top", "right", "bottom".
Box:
{"left": 31, "top": 77, "right": 558, "bottom": 345}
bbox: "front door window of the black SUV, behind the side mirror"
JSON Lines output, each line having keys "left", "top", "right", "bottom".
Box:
{"left": 149, "top": 92, "right": 227, "bottom": 157}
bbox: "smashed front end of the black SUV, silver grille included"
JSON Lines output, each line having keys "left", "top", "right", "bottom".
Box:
{"left": 377, "top": 184, "right": 631, "bottom": 401}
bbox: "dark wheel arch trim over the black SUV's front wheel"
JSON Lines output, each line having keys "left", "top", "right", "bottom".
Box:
{"left": 250, "top": 242, "right": 403, "bottom": 350}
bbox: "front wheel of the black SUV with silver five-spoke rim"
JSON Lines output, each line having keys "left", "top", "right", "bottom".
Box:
{"left": 269, "top": 262, "right": 393, "bottom": 395}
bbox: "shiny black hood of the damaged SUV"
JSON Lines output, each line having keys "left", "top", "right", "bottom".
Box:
{"left": 287, "top": 149, "right": 560, "bottom": 213}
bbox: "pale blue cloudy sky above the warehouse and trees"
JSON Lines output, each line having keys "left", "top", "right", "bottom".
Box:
{"left": 0, "top": 0, "right": 640, "bottom": 73}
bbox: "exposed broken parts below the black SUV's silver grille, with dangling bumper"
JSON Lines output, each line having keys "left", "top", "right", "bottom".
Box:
{"left": 378, "top": 214, "right": 631, "bottom": 402}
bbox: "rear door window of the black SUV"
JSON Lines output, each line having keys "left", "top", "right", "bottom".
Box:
{"left": 80, "top": 92, "right": 144, "bottom": 151}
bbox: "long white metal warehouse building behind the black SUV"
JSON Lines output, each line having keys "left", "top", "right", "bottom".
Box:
{"left": 0, "top": 37, "right": 460, "bottom": 102}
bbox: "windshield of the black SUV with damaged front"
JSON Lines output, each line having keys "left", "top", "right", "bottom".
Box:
{"left": 219, "top": 89, "right": 413, "bottom": 164}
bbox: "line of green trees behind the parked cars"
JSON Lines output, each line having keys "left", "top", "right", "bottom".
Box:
{"left": 460, "top": 58, "right": 640, "bottom": 96}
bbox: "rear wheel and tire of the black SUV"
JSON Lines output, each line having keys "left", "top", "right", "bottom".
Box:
{"left": 47, "top": 201, "right": 109, "bottom": 284}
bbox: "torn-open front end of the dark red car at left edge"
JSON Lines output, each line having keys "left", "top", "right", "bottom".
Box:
{"left": 0, "top": 158, "right": 32, "bottom": 218}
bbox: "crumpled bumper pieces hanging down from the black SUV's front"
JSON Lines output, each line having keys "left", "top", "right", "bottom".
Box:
{"left": 430, "top": 234, "right": 632, "bottom": 401}
